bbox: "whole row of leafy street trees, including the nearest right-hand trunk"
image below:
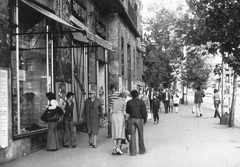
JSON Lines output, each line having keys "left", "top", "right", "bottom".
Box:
{"left": 142, "top": 0, "right": 240, "bottom": 127}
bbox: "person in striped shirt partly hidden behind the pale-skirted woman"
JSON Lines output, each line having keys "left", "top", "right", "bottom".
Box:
{"left": 107, "top": 85, "right": 119, "bottom": 138}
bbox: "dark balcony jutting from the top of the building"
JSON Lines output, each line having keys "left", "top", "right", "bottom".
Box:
{"left": 93, "top": 0, "right": 141, "bottom": 37}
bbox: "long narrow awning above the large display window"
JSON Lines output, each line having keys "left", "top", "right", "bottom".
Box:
{"left": 21, "top": 0, "right": 83, "bottom": 31}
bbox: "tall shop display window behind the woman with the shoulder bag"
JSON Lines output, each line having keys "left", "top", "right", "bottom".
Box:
{"left": 11, "top": 0, "right": 53, "bottom": 136}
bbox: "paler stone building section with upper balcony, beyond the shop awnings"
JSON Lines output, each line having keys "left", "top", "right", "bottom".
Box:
{"left": 96, "top": 0, "right": 145, "bottom": 92}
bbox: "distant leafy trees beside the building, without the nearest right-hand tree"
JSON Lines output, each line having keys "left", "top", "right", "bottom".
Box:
{"left": 144, "top": 1, "right": 212, "bottom": 91}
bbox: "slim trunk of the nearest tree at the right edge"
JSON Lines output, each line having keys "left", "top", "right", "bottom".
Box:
{"left": 229, "top": 72, "right": 237, "bottom": 127}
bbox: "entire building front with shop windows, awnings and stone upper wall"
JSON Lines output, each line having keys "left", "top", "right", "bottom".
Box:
{"left": 0, "top": 0, "right": 143, "bottom": 165}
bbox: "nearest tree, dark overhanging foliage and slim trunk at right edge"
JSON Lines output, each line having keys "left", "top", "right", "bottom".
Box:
{"left": 186, "top": 0, "right": 240, "bottom": 127}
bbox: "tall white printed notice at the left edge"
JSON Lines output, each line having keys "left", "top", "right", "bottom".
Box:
{"left": 0, "top": 69, "right": 9, "bottom": 148}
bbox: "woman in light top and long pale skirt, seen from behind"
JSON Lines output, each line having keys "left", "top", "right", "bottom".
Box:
{"left": 111, "top": 93, "right": 126, "bottom": 155}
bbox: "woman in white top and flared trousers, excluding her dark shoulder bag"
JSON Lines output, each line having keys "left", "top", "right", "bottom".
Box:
{"left": 46, "top": 92, "right": 59, "bottom": 151}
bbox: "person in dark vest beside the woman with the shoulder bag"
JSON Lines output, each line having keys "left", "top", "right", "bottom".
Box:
{"left": 63, "top": 92, "right": 76, "bottom": 148}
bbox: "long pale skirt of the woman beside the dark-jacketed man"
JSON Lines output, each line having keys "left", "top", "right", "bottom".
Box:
{"left": 112, "top": 112, "right": 125, "bottom": 139}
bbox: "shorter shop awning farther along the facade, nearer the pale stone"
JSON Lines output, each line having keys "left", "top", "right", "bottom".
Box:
{"left": 70, "top": 16, "right": 112, "bottom": 50}
